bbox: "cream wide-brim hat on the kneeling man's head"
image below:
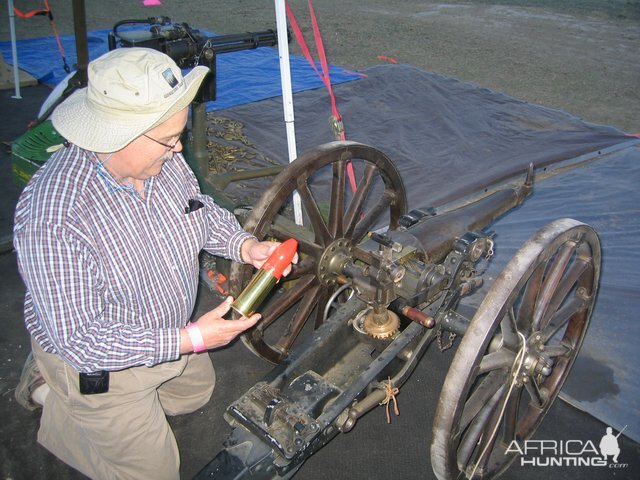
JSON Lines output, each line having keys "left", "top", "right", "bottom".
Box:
{"left": 51, "top": 47, "right": 209, "bottom": 153}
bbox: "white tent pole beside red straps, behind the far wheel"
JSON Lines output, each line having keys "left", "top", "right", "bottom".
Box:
{"left": 275, "top": 0, "right": 302, "bottom": 225}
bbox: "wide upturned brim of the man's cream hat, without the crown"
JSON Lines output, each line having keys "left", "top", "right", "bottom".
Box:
{"left": 51, "top": 65, "right": 209, "bottom": 153}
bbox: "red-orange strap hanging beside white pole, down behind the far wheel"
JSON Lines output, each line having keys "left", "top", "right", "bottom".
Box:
{"left": 285, "top": 0, "right": 357, "bottom": 192}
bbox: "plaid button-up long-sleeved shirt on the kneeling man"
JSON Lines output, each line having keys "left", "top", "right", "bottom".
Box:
{"left": 14, "top": 145, "right": 250, "bottom": 372}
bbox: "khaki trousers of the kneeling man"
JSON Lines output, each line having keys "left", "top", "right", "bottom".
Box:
{"left": 31, "top": 341, "right": 215, "bottom": 480}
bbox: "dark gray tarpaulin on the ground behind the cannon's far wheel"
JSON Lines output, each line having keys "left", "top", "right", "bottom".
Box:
{"left": 206, "top": 65, "right": 629, "bottom": 208}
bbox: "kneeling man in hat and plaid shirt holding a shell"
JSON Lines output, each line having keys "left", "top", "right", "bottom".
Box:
{"left": 14, "top": 48, "right": 296, "bottom": 479}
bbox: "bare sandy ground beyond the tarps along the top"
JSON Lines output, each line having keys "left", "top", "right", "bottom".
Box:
{"left": 0, "top": 0, "right": 640, "bottom": 133}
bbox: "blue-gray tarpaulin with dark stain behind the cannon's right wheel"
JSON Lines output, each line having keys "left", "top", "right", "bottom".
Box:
{"left": 460, "top": 147, "right": 640, "bottom": 441}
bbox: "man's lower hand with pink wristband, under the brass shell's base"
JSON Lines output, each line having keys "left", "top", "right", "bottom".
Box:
{"left": 180, "top": 297, "right": 260, "bottom": 354}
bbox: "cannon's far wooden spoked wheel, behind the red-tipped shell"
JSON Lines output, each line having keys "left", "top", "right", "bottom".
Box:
{"left": 229, "top": 142, "right": 407, "bottom": 363}
